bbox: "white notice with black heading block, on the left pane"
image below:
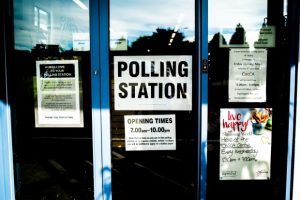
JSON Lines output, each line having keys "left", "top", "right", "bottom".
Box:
{"left": 35, "top": 60, "right": 83, "bottom": 127}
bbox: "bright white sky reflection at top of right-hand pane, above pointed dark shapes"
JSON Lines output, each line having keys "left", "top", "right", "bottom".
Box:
{"left": 208, "top": 0, "right": 267, "bottom": 44}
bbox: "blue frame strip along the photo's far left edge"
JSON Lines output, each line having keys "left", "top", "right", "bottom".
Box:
{"left": 0, "top": 1, "right": 15, "bottom": 200}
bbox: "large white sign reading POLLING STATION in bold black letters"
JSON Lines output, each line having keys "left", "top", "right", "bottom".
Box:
{"left": 114, "top": 55, "right": 192, "bottom": 111}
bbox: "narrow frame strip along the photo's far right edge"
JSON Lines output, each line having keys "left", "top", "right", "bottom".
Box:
{"left": 286, "top": 0, "right": 300, "bottom": 200}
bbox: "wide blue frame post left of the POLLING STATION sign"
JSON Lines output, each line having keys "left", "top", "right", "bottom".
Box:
{"left": 90, "top": 0, "right": 111, "bottom": 200}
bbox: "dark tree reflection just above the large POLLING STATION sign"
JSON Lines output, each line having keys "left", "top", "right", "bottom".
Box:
{"left": 130, "top": 28, "right": 194, "bottom": 54}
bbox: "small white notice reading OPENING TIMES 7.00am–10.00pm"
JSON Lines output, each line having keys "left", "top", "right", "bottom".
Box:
{"left": 124, "top": 115, "right": 176, "bottom": 151}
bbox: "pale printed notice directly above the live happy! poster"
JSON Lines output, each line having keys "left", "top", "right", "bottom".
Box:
{"left": 228, "top": 48, "right": 267, "bottom": 102}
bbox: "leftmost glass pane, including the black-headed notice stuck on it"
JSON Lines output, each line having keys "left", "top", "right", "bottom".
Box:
{"left": 9, "top": 0, "right": 93, "bottom": 199}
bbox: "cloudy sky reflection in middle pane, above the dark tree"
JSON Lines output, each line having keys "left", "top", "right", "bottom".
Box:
{"left": 110, "top": 0, "right": 195, "bottom": 43}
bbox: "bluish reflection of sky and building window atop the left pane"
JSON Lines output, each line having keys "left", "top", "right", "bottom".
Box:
{"left": 14, "top": 0, "right": 89, "bottom": 51}
